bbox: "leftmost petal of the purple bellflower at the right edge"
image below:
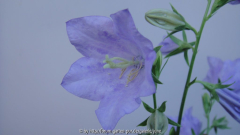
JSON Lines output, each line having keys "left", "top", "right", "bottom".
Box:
{"left": 204, "top": 57, "right": 223, "bottom": 83}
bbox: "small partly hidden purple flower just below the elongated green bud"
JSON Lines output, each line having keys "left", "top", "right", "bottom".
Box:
{"left": 159, "top": 36, "right": 179, "bottom": 55}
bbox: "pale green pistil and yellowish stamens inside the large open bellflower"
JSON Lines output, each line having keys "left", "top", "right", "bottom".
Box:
{"left": 103, "top": 55, "right": 144, "bottom": 87}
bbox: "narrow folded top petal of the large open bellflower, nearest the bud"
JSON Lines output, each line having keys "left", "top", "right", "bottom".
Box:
{"left": 110, "top": 9, "right": 153, "bottom": 58}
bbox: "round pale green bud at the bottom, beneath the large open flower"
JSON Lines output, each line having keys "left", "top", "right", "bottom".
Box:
{"left": 147, "top": 110, "right": 168, "bottom": 135}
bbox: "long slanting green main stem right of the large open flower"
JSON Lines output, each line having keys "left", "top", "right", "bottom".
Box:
{"left": 177, "top": 0, "right": 211, "bottom": 135}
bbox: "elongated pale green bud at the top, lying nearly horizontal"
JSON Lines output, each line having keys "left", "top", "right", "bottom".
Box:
{"left": 145, "top": 9, "right": 186, "bottom": 31}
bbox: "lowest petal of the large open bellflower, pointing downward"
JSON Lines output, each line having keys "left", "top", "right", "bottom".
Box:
{"left": 96, "top": 89, "right": 141, "bottom": 130}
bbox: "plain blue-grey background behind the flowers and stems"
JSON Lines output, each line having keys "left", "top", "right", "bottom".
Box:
{"left": 0, "top": 0, "right": 240, "bottom": 135}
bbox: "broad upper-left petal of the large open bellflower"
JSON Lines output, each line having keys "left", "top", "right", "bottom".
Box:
{"left": 66, "top": 13, "right": 141, "bottom": 60}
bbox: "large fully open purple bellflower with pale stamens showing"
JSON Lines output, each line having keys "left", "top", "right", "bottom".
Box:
{"left": 61, "top": 9, "right": 156, "bottom": 130}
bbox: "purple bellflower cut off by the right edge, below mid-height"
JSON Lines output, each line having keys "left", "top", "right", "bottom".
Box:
{"left": 205, "top": 57, "right": 240, "bottom": 123}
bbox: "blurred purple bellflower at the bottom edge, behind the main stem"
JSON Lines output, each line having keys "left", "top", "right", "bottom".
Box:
{"left": 168, "top": 107, "right": 202, "bottom": 135}
